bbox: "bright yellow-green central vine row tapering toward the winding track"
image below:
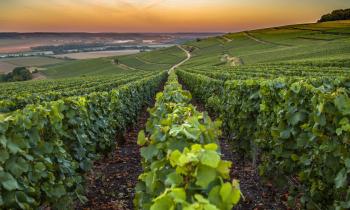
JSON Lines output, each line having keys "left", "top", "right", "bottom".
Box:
{"left": 134, "top": 73, "right": 241, "bottom": 210}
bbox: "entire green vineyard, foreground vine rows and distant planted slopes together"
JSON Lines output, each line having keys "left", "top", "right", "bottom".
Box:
{"left": 0, "top": 21, "right": 350, "bottom": 210}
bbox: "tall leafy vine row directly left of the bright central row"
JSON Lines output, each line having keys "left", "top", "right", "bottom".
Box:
{"left": 0, "top": 72, "right": 166, "bottom": 209}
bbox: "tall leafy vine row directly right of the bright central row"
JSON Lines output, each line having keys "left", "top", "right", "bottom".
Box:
{"left": 177, "top": 70, "right": 350, "bottom": 209}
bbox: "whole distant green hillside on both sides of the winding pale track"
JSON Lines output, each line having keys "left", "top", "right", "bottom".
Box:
{"left": 43, "top": 21, "right": 350, "bottom": 78}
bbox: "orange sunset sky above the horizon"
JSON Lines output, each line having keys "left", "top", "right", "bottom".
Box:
{"left": 0, "top": 0, "right": 350, "bottom": 33}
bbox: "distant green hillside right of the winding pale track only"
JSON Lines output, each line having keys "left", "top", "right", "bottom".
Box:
{"left": 182, "top": 21, "right": 350, "bottom": 66}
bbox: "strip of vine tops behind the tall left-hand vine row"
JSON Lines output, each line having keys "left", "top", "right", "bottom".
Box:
{"left": 0, "top": 72, "right": 159, "bottom": 112}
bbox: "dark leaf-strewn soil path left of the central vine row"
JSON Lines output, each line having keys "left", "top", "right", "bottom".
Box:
{"left": 75, "top": 107, "right": 148, "bottom": 210}
